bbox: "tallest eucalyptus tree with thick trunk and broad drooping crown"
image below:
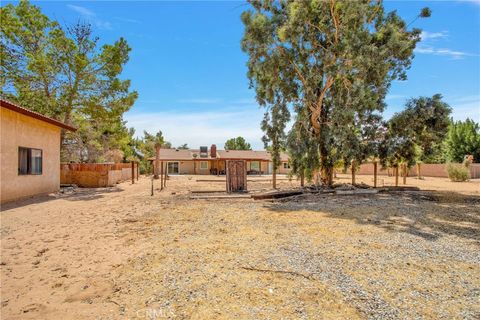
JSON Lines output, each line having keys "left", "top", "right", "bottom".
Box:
{"left": 242, "top": 0, "right": 430, "bottom": 184}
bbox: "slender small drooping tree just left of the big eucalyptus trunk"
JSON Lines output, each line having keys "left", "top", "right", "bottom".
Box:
{"left": 261, "top": 96, "right": 290, "bottom": 189}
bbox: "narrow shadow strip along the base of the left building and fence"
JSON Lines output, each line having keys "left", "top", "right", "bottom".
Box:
{"left": 1, "top": 186, "right": 124, "bottom": 212}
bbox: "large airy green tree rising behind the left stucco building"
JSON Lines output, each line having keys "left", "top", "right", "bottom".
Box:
{"left": 0, "top": 0, "right": 137, "bottom": 162}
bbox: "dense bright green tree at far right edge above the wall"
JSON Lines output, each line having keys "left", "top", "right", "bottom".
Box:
{"left": 445, "top": 119, "right": 480, "bottom": 162}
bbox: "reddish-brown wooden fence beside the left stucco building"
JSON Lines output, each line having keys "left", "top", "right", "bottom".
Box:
{"left": 60, "top": 163, "right": 138, "bottom": 188}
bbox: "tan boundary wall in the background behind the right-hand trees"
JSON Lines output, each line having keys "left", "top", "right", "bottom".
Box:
{"left": 356, "top": 163, "right": 480, "bottom": 179}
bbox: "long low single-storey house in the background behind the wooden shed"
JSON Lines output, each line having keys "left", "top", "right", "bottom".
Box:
{"left": 149, "top": 145, "right": 290, "bottom": 174}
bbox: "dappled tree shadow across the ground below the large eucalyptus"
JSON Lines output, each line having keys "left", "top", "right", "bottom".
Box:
{"left": 266, "top": 191, "right": 480, "bottom": 244}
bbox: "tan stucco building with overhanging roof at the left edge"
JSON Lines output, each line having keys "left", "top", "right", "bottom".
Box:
{"left": 0, "top": 100, "right": 76, "bottom": 203}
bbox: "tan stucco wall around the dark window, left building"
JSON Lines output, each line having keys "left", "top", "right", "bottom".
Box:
{"left": 0, "top": 108, "right": 60, "bottom": 202}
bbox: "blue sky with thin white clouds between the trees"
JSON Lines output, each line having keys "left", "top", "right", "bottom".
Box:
{"left": 4, "top": 1, "right": 480, "bottom": 149}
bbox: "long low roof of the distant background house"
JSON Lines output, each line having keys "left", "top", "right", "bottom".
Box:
{"left": 149, "top": 149, "right": 288, "bottom": 161}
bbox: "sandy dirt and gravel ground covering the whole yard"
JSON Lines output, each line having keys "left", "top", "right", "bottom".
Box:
{"left": 0, "top": 175, "right": 480, "bottom": 319}
